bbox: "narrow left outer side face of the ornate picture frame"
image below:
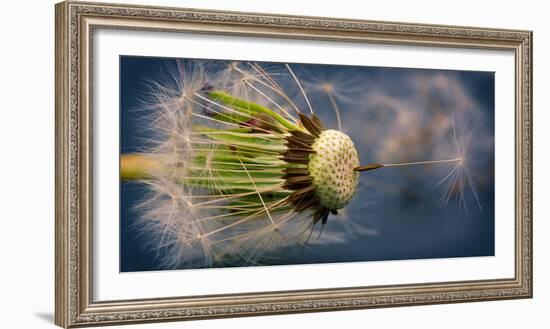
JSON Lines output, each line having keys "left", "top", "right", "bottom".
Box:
{"left": 54, "top": 2, "right": 70, "bottom": 328}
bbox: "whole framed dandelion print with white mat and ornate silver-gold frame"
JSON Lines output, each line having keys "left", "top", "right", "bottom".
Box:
{"left": 55, "top": 1, "right": 533, "bottom": 327}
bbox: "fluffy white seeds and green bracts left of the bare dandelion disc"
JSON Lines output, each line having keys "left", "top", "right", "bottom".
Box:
{"left": 136, "top": 60, "right": 355, "bottom": 268}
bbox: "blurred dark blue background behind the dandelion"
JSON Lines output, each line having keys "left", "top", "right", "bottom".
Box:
{"left": 120, "top": 56, "right": 495, "bottom": 272}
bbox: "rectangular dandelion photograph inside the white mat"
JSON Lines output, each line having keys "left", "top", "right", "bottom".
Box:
{"left": 119, "top": 55, "right": 495, "bottom": 272}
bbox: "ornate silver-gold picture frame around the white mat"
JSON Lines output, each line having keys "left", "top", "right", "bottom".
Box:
{"left": 55, "top": 1, "right": 533, "bottom": 328}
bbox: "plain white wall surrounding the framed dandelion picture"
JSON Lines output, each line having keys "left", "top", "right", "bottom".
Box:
{"left": 0, "top": 0, "right": 550, "bottom": 328}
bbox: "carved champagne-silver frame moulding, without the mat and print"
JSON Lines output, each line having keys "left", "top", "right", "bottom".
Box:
{"left": 55, "top": 0, "right": 533, "bottom": 328}
